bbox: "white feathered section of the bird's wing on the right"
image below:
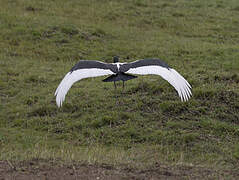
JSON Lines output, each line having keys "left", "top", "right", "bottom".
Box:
{"left": 126, "top": 65, "right": 192, "bottom": 101}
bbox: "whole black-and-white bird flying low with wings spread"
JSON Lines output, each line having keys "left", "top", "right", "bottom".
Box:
{"left": 55, "top": 56, "right": 192, "bottom": 107}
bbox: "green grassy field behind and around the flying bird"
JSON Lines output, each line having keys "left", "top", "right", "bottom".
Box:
{"left": 0, "top": 0, "right": 239, "bottom": 177}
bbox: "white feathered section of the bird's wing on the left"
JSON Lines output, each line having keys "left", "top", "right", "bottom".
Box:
{"left": 55, "top": 68, "right": 114, "bottom": 107}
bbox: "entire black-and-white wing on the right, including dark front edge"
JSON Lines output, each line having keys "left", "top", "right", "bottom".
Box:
{"left": 120, "top": 59, "right": 192, "bottom": 101}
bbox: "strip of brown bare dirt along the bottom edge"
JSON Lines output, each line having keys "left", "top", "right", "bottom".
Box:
{"left": 0, "top": 160, "right": 239, "bottom": 180}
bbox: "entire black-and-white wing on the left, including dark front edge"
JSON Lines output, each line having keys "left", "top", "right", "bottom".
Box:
{"left": 55, "top": 60, "right": 117, "bottom": 107}
